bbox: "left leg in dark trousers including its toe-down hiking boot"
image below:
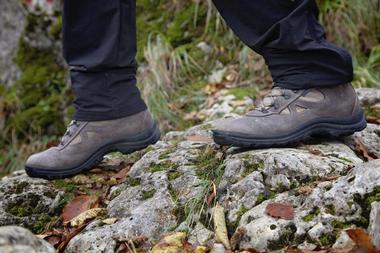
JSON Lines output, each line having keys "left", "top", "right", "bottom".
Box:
{"left": 26, "top": 0, "right": 160, "bottom": 179}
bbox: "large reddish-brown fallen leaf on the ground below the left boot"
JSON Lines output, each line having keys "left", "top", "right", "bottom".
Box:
{"left": 62, "top": 195, "right": 97, "bottom": 223}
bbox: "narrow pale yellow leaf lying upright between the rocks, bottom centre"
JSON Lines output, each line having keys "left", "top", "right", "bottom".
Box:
{"left": 213, "top": 204, "right": 231, "bottom": 250}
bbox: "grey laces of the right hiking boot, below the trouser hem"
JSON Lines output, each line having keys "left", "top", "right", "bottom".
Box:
{"left": 255, "top": 87, "right": 297, "bottom": 113}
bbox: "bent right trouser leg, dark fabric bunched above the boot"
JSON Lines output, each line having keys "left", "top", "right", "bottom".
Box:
{"left": 213, "top": 0, "right": 353, "bottom": 89}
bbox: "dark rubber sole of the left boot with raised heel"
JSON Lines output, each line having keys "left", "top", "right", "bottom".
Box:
{"left": 25, "top": 124, "right": 161, "bottom": 180}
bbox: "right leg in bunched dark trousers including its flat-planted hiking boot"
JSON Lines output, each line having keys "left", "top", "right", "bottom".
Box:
{"left": 213, "top": 0, "right": 366, "bottom": 148}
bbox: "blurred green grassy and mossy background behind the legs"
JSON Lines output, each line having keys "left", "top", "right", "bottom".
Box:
{"left": 0, "top": 0, "right": 380, "bottom": 174}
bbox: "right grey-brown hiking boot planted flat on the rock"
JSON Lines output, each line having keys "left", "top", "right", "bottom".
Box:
{"left": 213, "top": 84, "right": 367, "bottom": 148}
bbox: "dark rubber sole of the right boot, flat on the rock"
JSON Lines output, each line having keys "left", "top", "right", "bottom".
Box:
{"left": 213, "top": 112, "right": 367, "bottom": 148}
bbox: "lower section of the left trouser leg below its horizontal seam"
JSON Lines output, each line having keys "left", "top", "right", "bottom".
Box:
{"left": 70, "top": 68, "right": 147, "bottom": 121}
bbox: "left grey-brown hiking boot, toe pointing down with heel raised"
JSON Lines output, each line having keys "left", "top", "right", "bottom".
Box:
{"left": 25, "top": 110, "right": 160, "bottom": 179}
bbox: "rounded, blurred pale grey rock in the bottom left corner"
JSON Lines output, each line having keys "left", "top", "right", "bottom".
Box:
{"left": 0, "top": 226, "right": 56, "bottom": 253}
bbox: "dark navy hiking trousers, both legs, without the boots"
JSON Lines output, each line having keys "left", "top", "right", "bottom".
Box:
{"left": 63, "top": 0, "right": 353, "bottom": 121}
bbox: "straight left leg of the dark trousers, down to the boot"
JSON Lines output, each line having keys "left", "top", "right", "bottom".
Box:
{"left": 63, "top": 0, "right": 146, "bottom": 121}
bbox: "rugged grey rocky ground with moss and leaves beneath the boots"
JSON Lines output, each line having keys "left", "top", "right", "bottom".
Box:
{"left": 0, "top": 89, "right": 380, "bottom": 253}
